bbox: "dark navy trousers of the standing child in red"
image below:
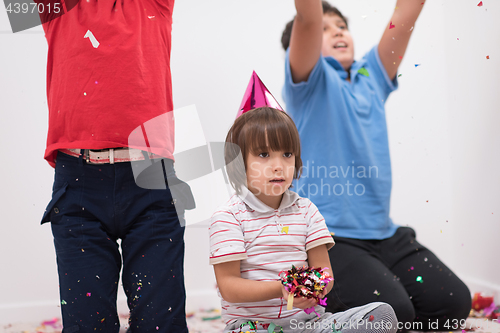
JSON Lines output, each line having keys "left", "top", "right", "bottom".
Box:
{"left": 42, "top": 153, "right": 188, "bottom": 333}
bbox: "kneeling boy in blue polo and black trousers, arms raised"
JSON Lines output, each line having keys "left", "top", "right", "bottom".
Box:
{"left": 282, "top": 0, "right": 470, "bottom": 330}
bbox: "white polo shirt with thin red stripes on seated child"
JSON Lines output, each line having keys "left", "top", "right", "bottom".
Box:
{"left": 209, "top": 188, "right": 335, "bottom": 323}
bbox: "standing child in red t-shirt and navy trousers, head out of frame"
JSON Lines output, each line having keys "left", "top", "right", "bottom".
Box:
{"left": 38, "top": 0, "right": 187, "bottom": 333}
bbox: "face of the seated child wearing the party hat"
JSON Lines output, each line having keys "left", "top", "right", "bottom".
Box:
{"left": 246, "top": 150, "right": 295, "bottom": 209}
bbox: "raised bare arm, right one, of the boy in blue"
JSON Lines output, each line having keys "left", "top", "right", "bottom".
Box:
{"left": 378, "top": 0, "right": 425, "bottom": 80}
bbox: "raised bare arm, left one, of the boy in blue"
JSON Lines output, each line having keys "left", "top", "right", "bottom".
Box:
{"left": 290, "top": 0, "right": 323, "bottom": 83}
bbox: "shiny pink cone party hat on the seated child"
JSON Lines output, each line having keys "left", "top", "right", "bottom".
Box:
{"left": 236, "top": 71, "right": 284, "bottom": 118}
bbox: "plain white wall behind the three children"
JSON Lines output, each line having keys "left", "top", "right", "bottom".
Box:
{"left": 0, "top": 0, "right": 500, "bottom": 324}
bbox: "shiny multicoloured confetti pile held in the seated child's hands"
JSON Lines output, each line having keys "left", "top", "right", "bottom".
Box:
{"left": 280, "top": 266, "right": 333, "bottom": 313}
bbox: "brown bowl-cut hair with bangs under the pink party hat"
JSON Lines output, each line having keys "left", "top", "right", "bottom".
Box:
{"left": 224, "top": 106, "right": 302, "bottom": 194}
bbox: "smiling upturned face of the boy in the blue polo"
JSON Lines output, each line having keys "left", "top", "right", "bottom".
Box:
{"left": 321, "top": 14, "right": 354, "bottom": 70}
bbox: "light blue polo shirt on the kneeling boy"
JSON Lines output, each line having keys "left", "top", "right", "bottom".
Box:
{"left": 283, "top": 47, "right": 398, "bottom": 239}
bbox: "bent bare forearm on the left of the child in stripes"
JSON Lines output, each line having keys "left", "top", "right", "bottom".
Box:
{"left": 214, "top": 260, "right": 282, "bottom": 303}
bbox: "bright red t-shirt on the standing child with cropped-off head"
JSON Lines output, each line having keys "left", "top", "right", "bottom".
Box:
{"left": 40, "top": 0, "right": 174, "bottom": 166}
